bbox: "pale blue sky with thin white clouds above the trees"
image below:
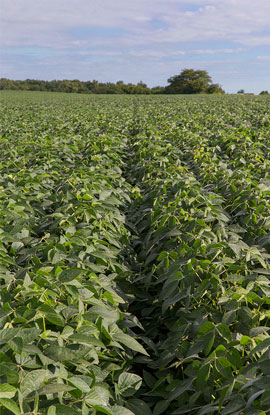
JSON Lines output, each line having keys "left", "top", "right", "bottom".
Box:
{"left": 0, "top": 0, "right": 270, "bottom": 93}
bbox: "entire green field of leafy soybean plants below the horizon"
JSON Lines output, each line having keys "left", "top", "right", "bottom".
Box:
{"left": 0, "top": 91, "right": 270, "bottom": 415}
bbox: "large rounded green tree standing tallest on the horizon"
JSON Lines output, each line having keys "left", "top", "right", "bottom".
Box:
{"left": 166, "top": 69, "right": 220, "bottom": 94}
